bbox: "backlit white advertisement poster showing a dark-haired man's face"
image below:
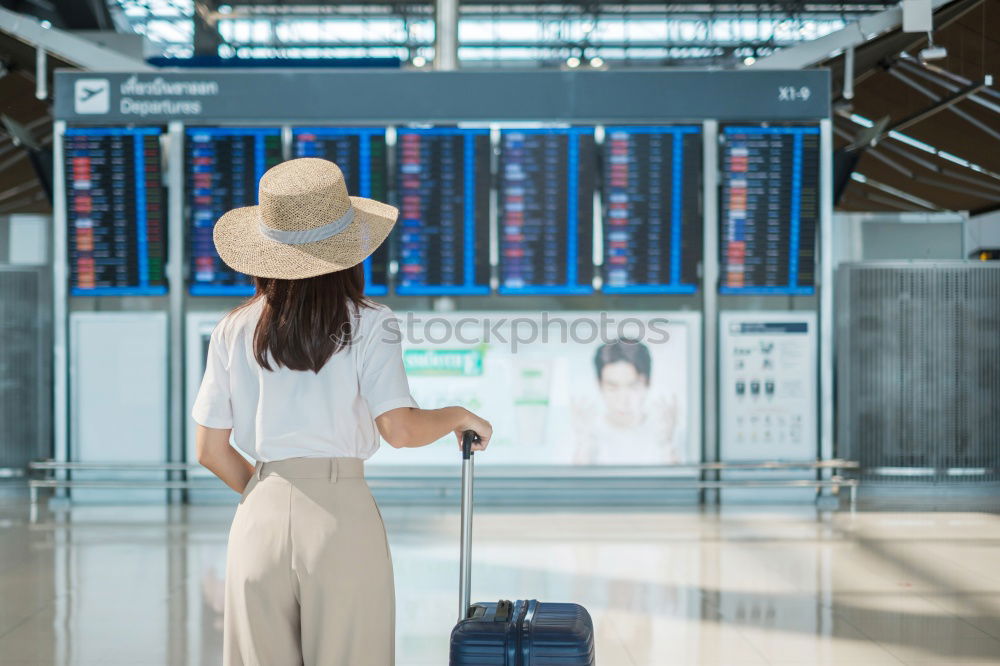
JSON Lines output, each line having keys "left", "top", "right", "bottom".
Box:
{"left": 371, "top": 312, "right": 701, "bottom": 466}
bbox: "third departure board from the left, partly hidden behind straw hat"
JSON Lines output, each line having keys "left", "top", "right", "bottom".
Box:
{"left": 292, "top": 127, "right": 389, "bottom": 296}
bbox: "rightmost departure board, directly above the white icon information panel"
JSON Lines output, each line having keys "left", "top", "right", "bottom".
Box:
{"left": 719, "top": 126, "right": 820, "bottom": 294}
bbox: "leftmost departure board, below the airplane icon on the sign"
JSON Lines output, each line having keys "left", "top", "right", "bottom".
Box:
{"left": 63, "top": 127, "right": 167, "bottom": 296}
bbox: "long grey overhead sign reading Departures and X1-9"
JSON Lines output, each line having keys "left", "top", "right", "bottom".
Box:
{"left": 53, "top": 69, "right": 830, "bottom": 124}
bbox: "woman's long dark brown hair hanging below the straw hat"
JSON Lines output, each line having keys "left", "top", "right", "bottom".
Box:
{"left": 248, "top": 264, "right": 372, "bottom": 372}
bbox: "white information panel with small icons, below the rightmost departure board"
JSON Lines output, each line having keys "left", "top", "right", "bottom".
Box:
{"left": 719, "top": 311, "right": 819, "bottom": 462}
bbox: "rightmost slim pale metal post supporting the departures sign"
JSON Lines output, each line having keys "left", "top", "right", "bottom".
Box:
{"left": 819, "top": 118, "right": 834, "bottom": 475}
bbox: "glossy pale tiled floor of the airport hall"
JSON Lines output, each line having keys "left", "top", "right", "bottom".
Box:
{"left": 0, "top": 490, "right": 1000, "bottom": 666}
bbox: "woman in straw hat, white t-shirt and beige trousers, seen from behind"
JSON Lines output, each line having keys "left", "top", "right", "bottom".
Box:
{"left": 192, "top": 158, "right": 492, "bottom": 666}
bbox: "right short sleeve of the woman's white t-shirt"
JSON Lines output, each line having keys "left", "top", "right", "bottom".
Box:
{"left": 359, "top": 308, "right": 417, "bottom": 418}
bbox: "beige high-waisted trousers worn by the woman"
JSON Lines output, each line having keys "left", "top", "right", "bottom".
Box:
{"left": 223, "top": 458, "right": 395, "bottom": 666}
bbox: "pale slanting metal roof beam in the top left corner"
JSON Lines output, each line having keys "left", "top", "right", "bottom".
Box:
{"left": 0, "top": 7, "right": 153, "bottom": 72}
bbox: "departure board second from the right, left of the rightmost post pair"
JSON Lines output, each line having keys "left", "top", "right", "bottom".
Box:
{"left": 603, "top": 125, "right": 703, "bottom": 294}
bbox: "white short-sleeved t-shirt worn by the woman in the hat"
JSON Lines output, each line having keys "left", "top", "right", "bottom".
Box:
{"left": 191, "top": 301, "right": 417, "bottom": 462}
